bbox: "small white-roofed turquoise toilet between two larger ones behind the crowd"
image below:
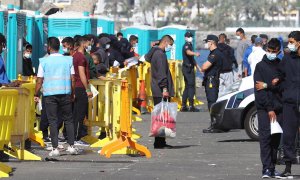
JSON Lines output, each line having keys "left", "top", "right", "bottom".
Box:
{"left": 91, "top": 16, "right": 115, "bottom": 36}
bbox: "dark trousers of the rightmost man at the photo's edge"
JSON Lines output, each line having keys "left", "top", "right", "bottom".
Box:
{"left": 282, "top": 103, "right": 300, "bottom": 162}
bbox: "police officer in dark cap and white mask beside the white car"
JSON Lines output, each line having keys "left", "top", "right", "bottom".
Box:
{"left": 200, "top": 35, "right": 223, "bottom": 133}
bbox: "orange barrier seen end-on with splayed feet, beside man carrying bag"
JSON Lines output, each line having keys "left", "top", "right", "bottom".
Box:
{"left": 100, "top": 81, "right": 151, "bottom": 158}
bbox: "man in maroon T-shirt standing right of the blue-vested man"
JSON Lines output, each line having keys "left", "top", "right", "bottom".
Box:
{"left": 73, "top": 37, "right": 93, "bottom": 146}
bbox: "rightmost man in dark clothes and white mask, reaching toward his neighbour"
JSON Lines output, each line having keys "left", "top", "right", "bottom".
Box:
{"left": 266, "top": 31, "right": 300, "bottom": 179}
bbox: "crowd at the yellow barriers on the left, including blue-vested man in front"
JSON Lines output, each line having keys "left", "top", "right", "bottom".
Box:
{"left": 32, "top": 33, "right": 138, "bottom": 156}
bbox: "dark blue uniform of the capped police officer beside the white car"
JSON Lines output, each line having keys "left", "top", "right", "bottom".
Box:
{"left": 202, "top": 49, "right": 223, "bottom": 110}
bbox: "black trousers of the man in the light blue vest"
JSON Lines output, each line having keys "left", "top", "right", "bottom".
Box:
{"left": 44, "top": 95, "right": 74, "bottom": 148}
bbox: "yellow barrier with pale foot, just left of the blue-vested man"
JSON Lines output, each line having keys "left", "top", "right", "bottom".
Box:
{"left": 4, "top": 87, "right": 41, "bottom": 160}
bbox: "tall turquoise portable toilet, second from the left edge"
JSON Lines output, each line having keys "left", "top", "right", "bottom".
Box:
{"left": 6, "top": 11, "right": 26, "bottom": 80}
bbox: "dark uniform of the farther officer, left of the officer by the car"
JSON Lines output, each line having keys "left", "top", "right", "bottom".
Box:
{"left": 182, "top": 42, "right": 196, "bottom": 107}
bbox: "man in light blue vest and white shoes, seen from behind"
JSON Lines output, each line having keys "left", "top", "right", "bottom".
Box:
{"left": 34, "top": 37, "right": 78, "bottom": 156}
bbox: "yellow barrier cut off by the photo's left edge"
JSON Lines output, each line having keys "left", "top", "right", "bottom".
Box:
{"left": 0, "top": 89, "right": 18, "bottom": 178}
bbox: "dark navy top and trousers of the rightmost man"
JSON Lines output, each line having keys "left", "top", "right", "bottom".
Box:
{"left": 278, "top": 53, "right": 300, "bottom": 163}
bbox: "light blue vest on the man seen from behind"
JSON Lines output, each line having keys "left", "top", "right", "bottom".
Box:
{"left": 40, "top": 56, "right": 73, "bottom": 96}
